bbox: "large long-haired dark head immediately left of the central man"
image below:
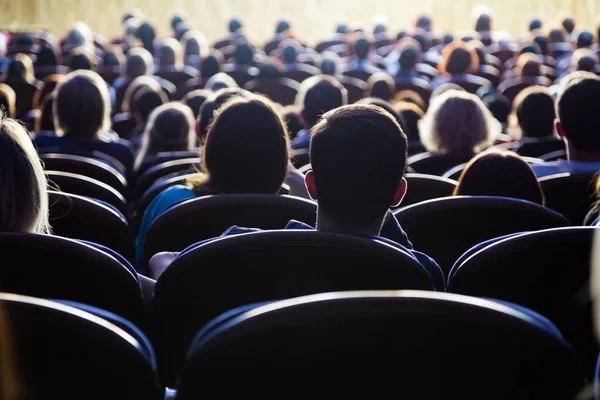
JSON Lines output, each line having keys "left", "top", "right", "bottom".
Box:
{"left": 201, "top": 95, "right": 289, "bottom": 194}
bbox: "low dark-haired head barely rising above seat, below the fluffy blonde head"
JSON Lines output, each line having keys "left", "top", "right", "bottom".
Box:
{"left": 454, "top": 151, "right": 544, "bottom": 205}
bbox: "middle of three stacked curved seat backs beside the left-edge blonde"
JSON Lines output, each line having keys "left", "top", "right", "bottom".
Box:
{"left": 46, "top": 171, "right": 128, "bottom": 216}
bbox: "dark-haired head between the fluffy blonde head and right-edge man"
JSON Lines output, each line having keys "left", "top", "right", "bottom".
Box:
{"left": 513, "top": 86, "right": 556, "bottom": 138}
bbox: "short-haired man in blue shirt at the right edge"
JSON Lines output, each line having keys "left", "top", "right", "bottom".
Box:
{"left": 532, "top": 72, "right": 600, "bottom": 177}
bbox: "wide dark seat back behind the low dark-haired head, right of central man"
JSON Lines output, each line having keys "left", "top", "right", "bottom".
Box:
{"left": 390, "top": 196, "right": 569, "bottom": 274}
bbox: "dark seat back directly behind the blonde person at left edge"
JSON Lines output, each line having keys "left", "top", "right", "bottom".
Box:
{"left": 0, "top": 233, "right": 143, "bottom": 323}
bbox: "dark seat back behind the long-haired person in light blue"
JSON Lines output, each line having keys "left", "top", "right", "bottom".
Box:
{"left": 144, "top": 194, "right": 317, "bottom": 263}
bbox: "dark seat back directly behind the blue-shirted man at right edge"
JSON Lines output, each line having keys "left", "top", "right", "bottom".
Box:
{"left": 539, "top": 173, "right": 597, "bottom": 225}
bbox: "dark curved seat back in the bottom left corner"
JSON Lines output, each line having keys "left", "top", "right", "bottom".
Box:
{"left": 0, "top": 293, "right": 164, "bottom": 400}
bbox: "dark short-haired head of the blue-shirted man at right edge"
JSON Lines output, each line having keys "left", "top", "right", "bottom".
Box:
{"left": 557, "top": 76, "right": 600, "bottom": 152}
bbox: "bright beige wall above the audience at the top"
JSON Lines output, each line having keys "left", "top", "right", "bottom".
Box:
{"left": 0, "top": 0, "right": 600, "bottom": 42}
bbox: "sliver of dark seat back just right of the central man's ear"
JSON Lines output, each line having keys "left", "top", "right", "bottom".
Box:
{"left": 400, "top": 174, "right": 456, "bottom": 207}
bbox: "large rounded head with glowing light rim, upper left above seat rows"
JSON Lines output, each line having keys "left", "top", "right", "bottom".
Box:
{"left": 54, "top": 70, "right": 111, "bottom": 139}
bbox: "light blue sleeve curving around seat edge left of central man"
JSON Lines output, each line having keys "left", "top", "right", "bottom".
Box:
{"left": 135, "top": 185, "right": 196, "bottom": 275}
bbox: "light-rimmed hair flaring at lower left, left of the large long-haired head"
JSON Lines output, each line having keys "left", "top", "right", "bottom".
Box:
{"left": 135, "top": 102, "right": 196, "bottom": 170}
